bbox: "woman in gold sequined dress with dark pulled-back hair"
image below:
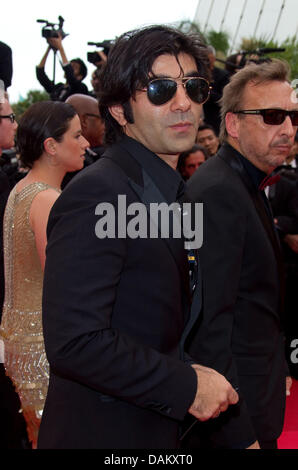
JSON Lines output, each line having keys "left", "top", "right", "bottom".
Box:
{"left": 0, "top": 101, "right": 88, "bottom": 448}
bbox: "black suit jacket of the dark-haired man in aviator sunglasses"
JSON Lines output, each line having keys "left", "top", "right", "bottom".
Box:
{"left": 39, "top": 138, "right": 198, "bottom": 449}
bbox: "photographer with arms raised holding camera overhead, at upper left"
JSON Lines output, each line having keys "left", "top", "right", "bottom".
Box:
{"left": 36, "top": 34, "right": 88, "bottom": 101}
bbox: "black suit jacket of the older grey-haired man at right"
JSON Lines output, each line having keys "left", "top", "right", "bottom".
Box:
{"left": 186, "top": 144, "right": 285, "bottom": 448}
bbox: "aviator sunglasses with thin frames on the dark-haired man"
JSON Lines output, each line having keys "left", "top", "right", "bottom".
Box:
{"left": 144, "top": 77, "right": 211, "bottom": 106}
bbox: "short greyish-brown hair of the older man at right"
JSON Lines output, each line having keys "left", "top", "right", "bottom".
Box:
{"left": 219, "top": 59, "right": 290, "bottom": 143}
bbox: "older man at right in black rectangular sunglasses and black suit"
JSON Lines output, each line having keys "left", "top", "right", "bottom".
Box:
{"left": 186, "top": 61, "right": 298, "bottom": 449}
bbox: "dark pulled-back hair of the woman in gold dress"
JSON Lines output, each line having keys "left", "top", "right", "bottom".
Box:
{"left": 17, "top": 101, "right": 77, "bottom": 168}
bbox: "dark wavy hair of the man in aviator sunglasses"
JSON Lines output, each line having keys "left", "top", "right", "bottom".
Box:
{"left": 99, "top": 25, "right": 210, "bottom": 144}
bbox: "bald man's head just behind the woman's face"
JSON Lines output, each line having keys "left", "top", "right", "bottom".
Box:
{"left": 66, "top": 94, "right": 104, "bottom": 148}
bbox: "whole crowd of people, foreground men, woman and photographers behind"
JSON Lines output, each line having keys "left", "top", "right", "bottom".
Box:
{"left": 0, "top": 26, "right": 298, "bottom": 449}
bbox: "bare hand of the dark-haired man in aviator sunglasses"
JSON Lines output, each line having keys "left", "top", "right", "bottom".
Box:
{"left": 188, "top": 364, "right": 239, "bottom": 421}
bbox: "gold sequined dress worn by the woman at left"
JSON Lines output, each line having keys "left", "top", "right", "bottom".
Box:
{"left": 0, "top": 183, "right": 58, "bottom": 442}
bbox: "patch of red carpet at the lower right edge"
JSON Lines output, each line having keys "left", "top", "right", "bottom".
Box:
{"left": 278, "top": 380, "right": 298, "bottom": 449}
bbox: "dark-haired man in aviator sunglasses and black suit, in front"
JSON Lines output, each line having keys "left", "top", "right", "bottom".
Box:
{"left": 39, "top": 26, "right": 238, "bottom": 449}
